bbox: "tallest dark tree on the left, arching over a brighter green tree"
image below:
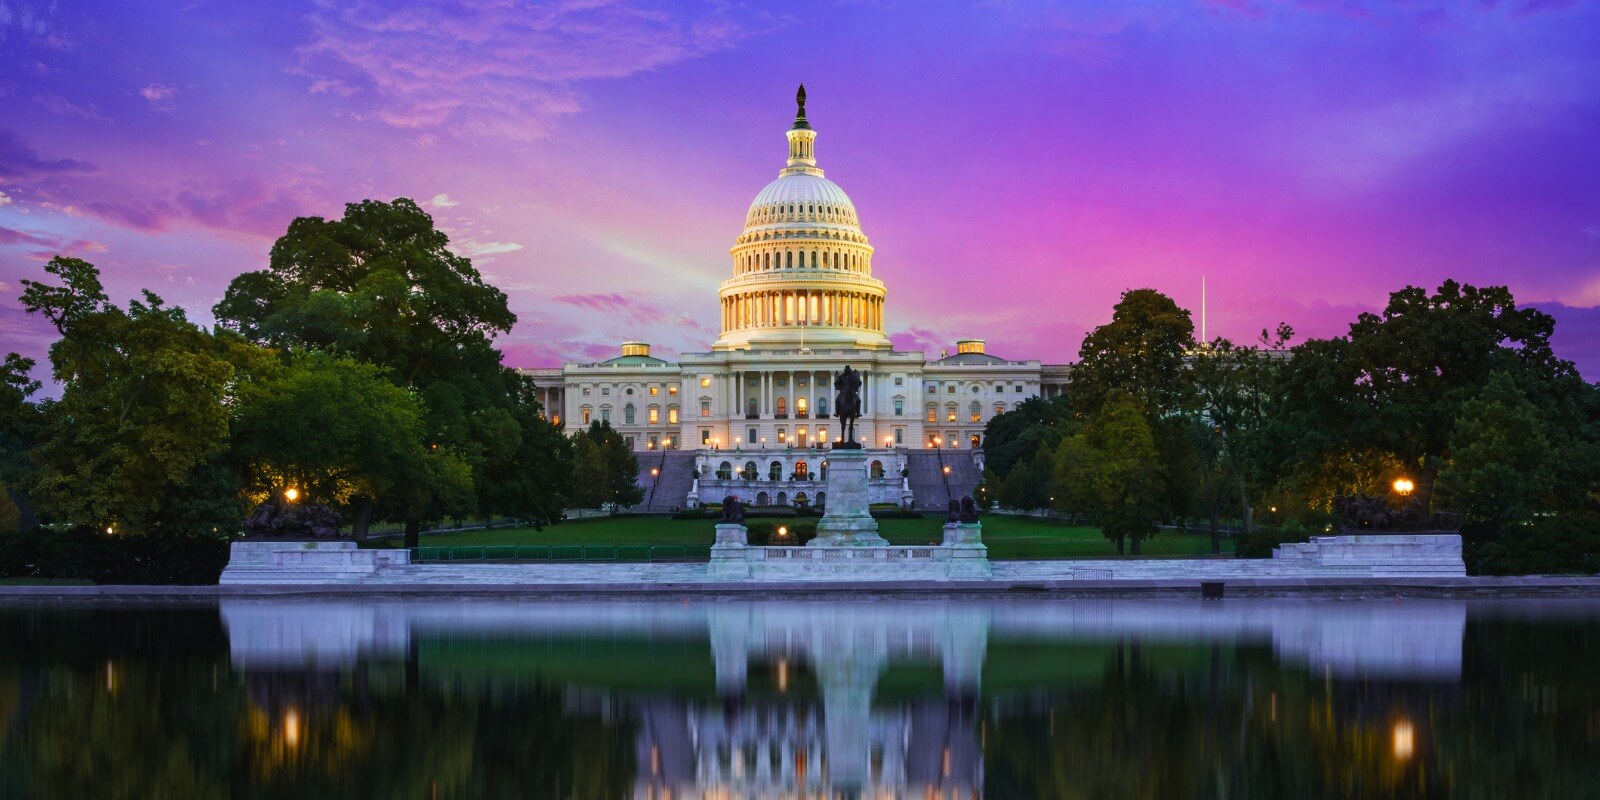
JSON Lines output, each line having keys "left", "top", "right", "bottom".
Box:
{"left": 214, "top": 198, "right": 560, "bottom": 546}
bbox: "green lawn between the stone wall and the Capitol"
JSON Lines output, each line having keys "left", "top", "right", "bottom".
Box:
{"left": 374, "top": 515, "right": 1232, "bottom": 558}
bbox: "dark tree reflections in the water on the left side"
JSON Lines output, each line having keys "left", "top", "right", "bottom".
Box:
{"left": 0, "top": 608, "right": 634, "bottom": 798}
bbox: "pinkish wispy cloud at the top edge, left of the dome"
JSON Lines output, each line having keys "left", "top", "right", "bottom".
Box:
{"left": 298, "top": 0, "right": 777, "bottom": 141}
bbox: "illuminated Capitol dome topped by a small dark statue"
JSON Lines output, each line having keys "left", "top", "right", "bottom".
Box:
{"left": 712, "top": 86, "right": 890, "bottom": 350}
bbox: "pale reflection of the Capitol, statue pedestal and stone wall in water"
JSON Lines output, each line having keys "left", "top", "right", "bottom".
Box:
{"left": 222, "top": 600, "right": 1466, "bottom": 798}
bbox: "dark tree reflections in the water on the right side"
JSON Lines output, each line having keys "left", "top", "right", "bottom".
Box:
{"left": 984, "top": 624, "right": 1600, "bottom": 798}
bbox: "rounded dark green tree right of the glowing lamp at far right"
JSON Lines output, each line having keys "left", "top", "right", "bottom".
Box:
{"left": 1438, "top": 373, "right": 1555, "bottom": 528}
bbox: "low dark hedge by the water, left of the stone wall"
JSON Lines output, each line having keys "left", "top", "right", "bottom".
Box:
{"left": 0, "top": 528, "right": 229, "bottom": 584}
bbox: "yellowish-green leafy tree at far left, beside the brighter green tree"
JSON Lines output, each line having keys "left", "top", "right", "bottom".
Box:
{"left": 22, "top": 258, "right": 234, "bottom": 533}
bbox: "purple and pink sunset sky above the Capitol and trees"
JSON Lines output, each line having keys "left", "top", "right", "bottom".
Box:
{"left": 0, "top": 0, "right": 1600, "bottom": 379}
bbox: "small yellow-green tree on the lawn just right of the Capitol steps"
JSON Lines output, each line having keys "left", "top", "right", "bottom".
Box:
{"left": 1054, "top": 389, "right": 1166, "bottom": 555}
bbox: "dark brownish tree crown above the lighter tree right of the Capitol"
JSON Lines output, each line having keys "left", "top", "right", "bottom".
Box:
{"left": 1067, "top": 290, "right": 1195, "bottom": 419}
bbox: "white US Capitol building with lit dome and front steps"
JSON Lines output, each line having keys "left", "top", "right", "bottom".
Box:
{"left": 525, "top": 86, "right": 1067, "bottom": 510}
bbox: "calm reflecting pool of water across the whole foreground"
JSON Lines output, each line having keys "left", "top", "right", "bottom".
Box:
{"left": 0, "top": 598, "right": 1600, "bottom": 798}
